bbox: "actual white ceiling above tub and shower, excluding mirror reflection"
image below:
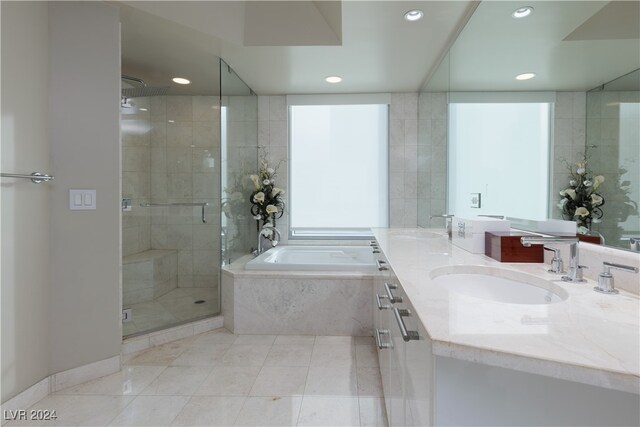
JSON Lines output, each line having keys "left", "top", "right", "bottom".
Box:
{"left": 115, "top": 0, "right": 476, "bottom": 95}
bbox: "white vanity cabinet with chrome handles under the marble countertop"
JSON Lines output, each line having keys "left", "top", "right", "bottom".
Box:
{"left": 373, "top": 237, "right": 640, "bottom": 427}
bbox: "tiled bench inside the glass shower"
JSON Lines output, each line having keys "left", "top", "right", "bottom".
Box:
{"left": 122, "top": 249, "right": 178, "bottom": 306}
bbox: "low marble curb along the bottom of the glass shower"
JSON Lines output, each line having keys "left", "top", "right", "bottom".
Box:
{"left": 121, "top": 315, "right": 224, "bottom": 356}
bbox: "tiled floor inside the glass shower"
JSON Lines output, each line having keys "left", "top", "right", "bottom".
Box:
{"left": 122, "top": 288, "right": 219, "bottom": 336}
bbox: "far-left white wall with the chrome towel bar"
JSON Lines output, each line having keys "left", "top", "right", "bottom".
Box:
{"left": 0, "top": 2, "right": 51, "bottom": 402}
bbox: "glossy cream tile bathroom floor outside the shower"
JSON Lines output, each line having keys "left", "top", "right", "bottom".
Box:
{"left": 7, "top": 329, "right": 387, "bottom": 426}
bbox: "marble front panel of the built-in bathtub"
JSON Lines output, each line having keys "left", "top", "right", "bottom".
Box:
{"left": 222, "top": 267, "right": 373, "bottom": 336}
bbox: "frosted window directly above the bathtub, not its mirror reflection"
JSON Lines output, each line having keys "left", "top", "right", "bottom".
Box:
{"left": 289, "top": 105, "right": 388, "bottom": 235}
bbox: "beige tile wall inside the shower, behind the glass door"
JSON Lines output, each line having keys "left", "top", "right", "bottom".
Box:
{"left": 123, "top": 96, "right": 220, "bottom": 287}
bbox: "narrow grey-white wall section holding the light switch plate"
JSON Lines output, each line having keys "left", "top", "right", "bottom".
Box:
{"left": 49, "top": 2, "right": 122, "bottom": 373}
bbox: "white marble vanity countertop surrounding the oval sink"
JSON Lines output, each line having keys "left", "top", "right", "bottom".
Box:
{"left": 374, "top": 229, "right": 640, "bottom": 394}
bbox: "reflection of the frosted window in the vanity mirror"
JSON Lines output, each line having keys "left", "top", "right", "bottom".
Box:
{"left": 448, "top": 103, "right": 550, "bottom": 220}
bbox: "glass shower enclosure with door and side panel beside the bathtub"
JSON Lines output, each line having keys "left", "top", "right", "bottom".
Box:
{"left": 121, "top": 58, "right": 257, "bottom": 337}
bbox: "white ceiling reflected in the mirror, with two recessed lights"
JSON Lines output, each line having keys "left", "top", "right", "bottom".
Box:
{"left": 440, "top": 1, "right": 640, "bottom": 91}
